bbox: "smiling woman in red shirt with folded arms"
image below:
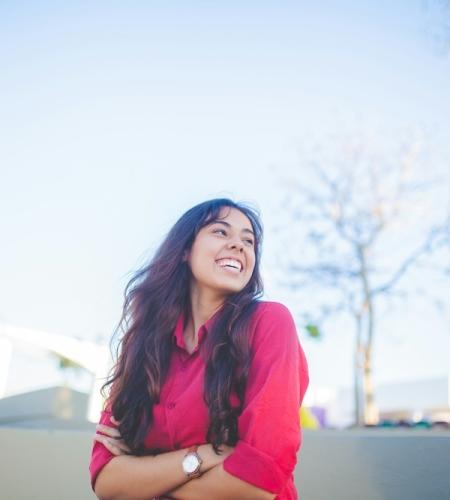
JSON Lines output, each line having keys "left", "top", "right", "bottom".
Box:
{"left": 90, "top": 199, "right": 308, "bottom": 500}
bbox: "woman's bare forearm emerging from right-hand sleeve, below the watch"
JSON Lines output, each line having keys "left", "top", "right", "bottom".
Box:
{"left": 166, "top": 464, "right": 276, "bottom": 500}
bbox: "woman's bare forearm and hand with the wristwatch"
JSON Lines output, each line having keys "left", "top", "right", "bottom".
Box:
{"left": 95, "top": 435, "right": 232, "bottom": 500}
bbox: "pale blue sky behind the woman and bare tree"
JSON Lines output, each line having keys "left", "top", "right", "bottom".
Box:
{"left": 0, "top": 0, "right": 450, "bottom": 398}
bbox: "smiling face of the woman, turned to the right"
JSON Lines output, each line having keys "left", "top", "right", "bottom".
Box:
{"left": 186, "top": 207, "right": 255, "bottom": 295}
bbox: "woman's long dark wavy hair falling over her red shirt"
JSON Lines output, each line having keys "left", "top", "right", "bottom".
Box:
{"left": 102, "top": 198, "right": 263, "bottom": 455}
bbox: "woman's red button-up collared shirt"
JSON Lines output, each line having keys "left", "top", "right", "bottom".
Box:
{"left": 89, "top": 301, "right": 309, "bottom": 500}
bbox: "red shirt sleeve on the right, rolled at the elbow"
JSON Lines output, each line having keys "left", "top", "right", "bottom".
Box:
{"left": 223, "top": 302, "right": 309, "bottom": 494}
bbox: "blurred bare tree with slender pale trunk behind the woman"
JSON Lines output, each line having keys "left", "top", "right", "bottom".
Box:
{"left": 270, "top": 133, "right": 449, "bottom": 425}
